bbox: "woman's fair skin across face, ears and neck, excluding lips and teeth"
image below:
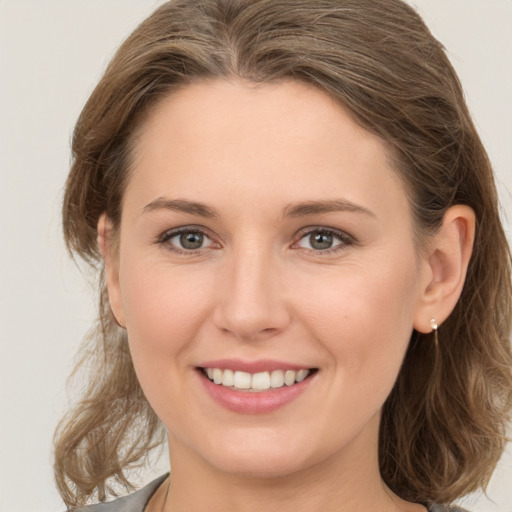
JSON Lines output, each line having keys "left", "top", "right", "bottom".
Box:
{"left": 98, "top": 81, "right": 474, "bottom": 512}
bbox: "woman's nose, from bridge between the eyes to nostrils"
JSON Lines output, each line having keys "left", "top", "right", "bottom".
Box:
{"left": 214, "top": 243, "right": 290, "bottom": 341}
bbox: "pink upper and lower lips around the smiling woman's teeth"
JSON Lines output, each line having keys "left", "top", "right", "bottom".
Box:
{"left": 196, "top": 360, "right": 318, "bottom": 415}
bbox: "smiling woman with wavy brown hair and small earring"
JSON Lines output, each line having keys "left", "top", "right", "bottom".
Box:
{"left": 55, "top": 0, "right": 512, "bottom": 512}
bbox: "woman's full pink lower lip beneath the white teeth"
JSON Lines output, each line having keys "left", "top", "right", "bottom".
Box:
{"left": 198, "top": 370, "right": 314, "bottom": 414}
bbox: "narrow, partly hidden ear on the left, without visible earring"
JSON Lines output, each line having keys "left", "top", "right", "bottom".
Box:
{"left": 97, "top": 213, "right": 126, "bottom": 328}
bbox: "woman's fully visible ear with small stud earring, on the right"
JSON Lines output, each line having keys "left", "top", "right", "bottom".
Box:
{"left": 414, "top": 205, "right": 476, "bottom": 333}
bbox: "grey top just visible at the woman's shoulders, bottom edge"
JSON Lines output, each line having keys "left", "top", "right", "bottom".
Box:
{"left": 68, "top": 474, "right": 466, "bottom": 512}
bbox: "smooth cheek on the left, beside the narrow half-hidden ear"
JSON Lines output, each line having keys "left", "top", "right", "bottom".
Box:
{"left": 120, "top": 257, "right": 219, "bottom": 428}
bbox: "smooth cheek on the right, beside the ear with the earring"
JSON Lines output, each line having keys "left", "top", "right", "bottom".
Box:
{"left": 297, "top": 257, "right": 417, "bottom": 382}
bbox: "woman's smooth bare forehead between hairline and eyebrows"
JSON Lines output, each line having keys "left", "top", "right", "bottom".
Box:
{"left": 127, "top": 81, "right": 407, "bottom": 222}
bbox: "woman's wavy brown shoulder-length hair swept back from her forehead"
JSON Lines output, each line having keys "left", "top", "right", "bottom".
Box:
{"left": 55, "top": 0, "right": 512, "bottom": 505}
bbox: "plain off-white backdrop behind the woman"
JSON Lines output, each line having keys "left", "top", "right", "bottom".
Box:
{"left": 0, "top": 0, "right": 512, "bottom": 512}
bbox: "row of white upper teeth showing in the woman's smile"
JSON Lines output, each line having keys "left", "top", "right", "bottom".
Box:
{"left": 204, "top": 368, "right": 311, "bottom": 391}
